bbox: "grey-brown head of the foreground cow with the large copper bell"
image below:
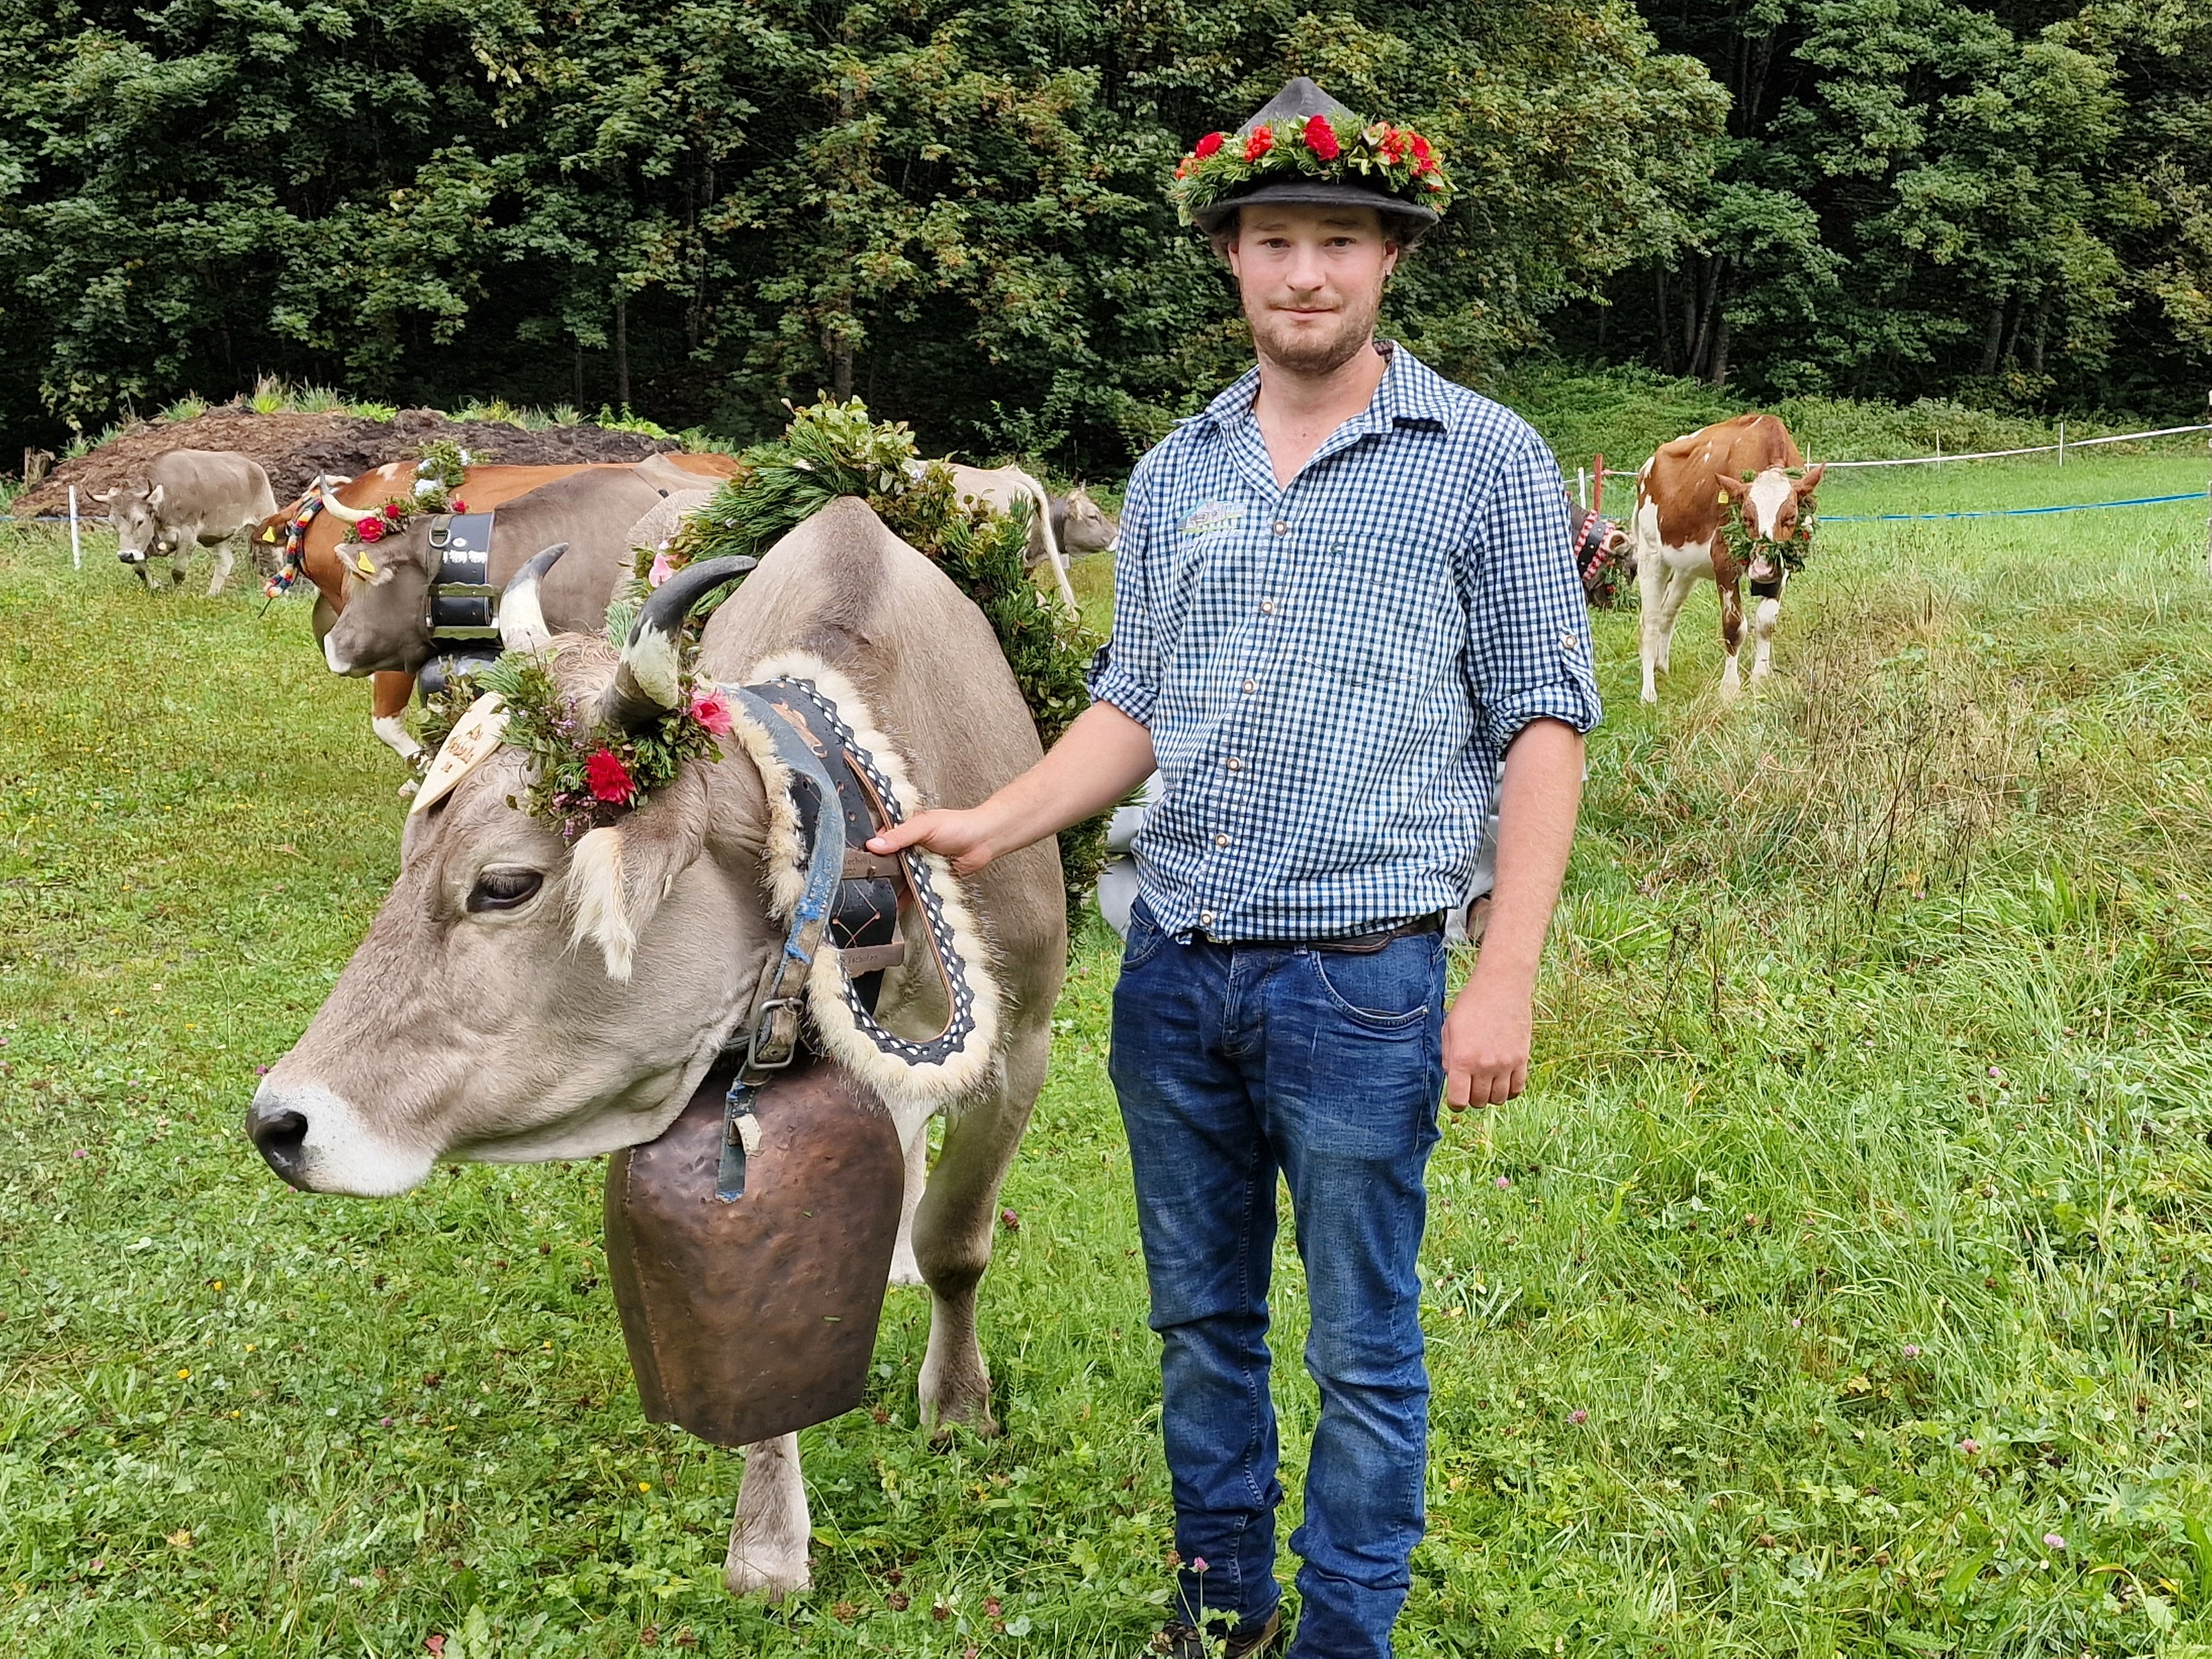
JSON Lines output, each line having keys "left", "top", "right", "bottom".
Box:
{"left": 246, "top": 555, "right": 781, "bottom": 1197}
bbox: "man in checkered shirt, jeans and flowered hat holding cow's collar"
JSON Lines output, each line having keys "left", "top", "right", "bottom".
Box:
{"left": 872, "top": 80, "right": 1599, "bottom": 1659}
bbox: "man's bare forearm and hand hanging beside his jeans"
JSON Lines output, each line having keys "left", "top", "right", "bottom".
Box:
{"left": 1442, "top": 719, "right": 1582, "bottom": 1113}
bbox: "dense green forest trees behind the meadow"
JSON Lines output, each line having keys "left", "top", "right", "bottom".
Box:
{"left": 0, "top": 0, "right": 2212, "bottom": 473}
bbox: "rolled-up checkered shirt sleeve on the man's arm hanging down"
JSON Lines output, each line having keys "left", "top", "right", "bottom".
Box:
{"left": 1462, "top": 431, "right": 1604, "bottom": 754}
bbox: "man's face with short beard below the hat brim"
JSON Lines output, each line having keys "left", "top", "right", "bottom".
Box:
{"left": 1228, "top": 206, "right": 1398, "bottom": 374}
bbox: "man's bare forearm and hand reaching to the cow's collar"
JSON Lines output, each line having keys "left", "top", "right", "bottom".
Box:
{"left": 867, "top": 703, "right": 1159, "bottom": 887}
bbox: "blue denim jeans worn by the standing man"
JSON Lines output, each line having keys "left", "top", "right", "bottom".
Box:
{"left": 1113, "top": 900, "right": 1444, "bottom": 1659}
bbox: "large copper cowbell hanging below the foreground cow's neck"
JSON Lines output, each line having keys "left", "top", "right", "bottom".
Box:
{"left": 606, "top": 1060, "right": 905, "bottom": 1447}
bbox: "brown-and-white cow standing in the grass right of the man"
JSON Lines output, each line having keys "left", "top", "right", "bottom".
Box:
{"left": 1630, "top": 414, "right": 1820, "bottom": 703}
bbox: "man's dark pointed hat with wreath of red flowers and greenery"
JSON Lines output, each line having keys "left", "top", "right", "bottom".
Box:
{"left": 1168, "top": 75, "right": 1451, "bottom": 237}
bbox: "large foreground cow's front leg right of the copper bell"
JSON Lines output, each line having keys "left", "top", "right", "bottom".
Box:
{"left": 914, "top": 1035, "right": 1053, "bottom": 1433}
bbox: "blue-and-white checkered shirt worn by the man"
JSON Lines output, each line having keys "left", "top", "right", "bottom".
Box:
{"left": 1091, "top": 347, "right": 1599, "bottom": 940}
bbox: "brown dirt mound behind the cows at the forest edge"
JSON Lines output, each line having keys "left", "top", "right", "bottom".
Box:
{"left": 13, "top": 407, "right": 681, "bottom": 518}
